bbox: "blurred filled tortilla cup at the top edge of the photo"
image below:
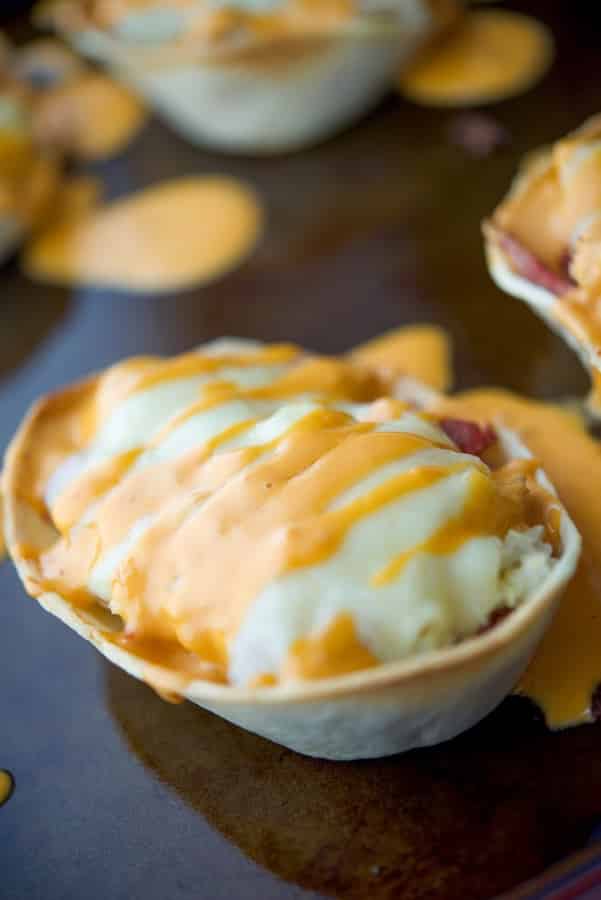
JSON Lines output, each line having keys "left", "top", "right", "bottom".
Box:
{"left": 37, "top": 0, "right": 459, "bottom": 154}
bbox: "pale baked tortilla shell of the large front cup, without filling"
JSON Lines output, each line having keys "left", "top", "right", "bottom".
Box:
{"left": 3, "top": 358, "right": 580, "bottom": 760}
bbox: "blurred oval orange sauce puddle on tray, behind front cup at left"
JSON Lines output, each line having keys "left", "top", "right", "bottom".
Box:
{"left": 23, "top": 176, "right": 263, "bottom": 291}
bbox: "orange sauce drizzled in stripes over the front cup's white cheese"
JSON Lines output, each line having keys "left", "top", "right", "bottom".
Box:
{"left": 12, "top": 328, "right": 550, "bottom": 699}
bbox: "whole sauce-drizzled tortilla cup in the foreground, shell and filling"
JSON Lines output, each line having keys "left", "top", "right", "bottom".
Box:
{"left": 4, "top": 341, "right": 580, "bottom": 759}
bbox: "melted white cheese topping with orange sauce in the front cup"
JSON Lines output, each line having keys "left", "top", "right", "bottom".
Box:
{"left": 19, "top": 343, "right": 541, "bottom": 685}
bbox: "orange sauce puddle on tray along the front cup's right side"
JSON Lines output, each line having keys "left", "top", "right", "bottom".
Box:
{"left": 439, "top": 389, "right": 601, "bottom": 728}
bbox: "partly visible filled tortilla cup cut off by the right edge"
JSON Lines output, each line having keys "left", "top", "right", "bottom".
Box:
{"left": 484, "top": 116, "right": 601, "bottom": 417}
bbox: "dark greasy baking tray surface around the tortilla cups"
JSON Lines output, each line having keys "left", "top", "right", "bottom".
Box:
{"left": 0, "top": 2, "right": 601, "bottom": 900}
